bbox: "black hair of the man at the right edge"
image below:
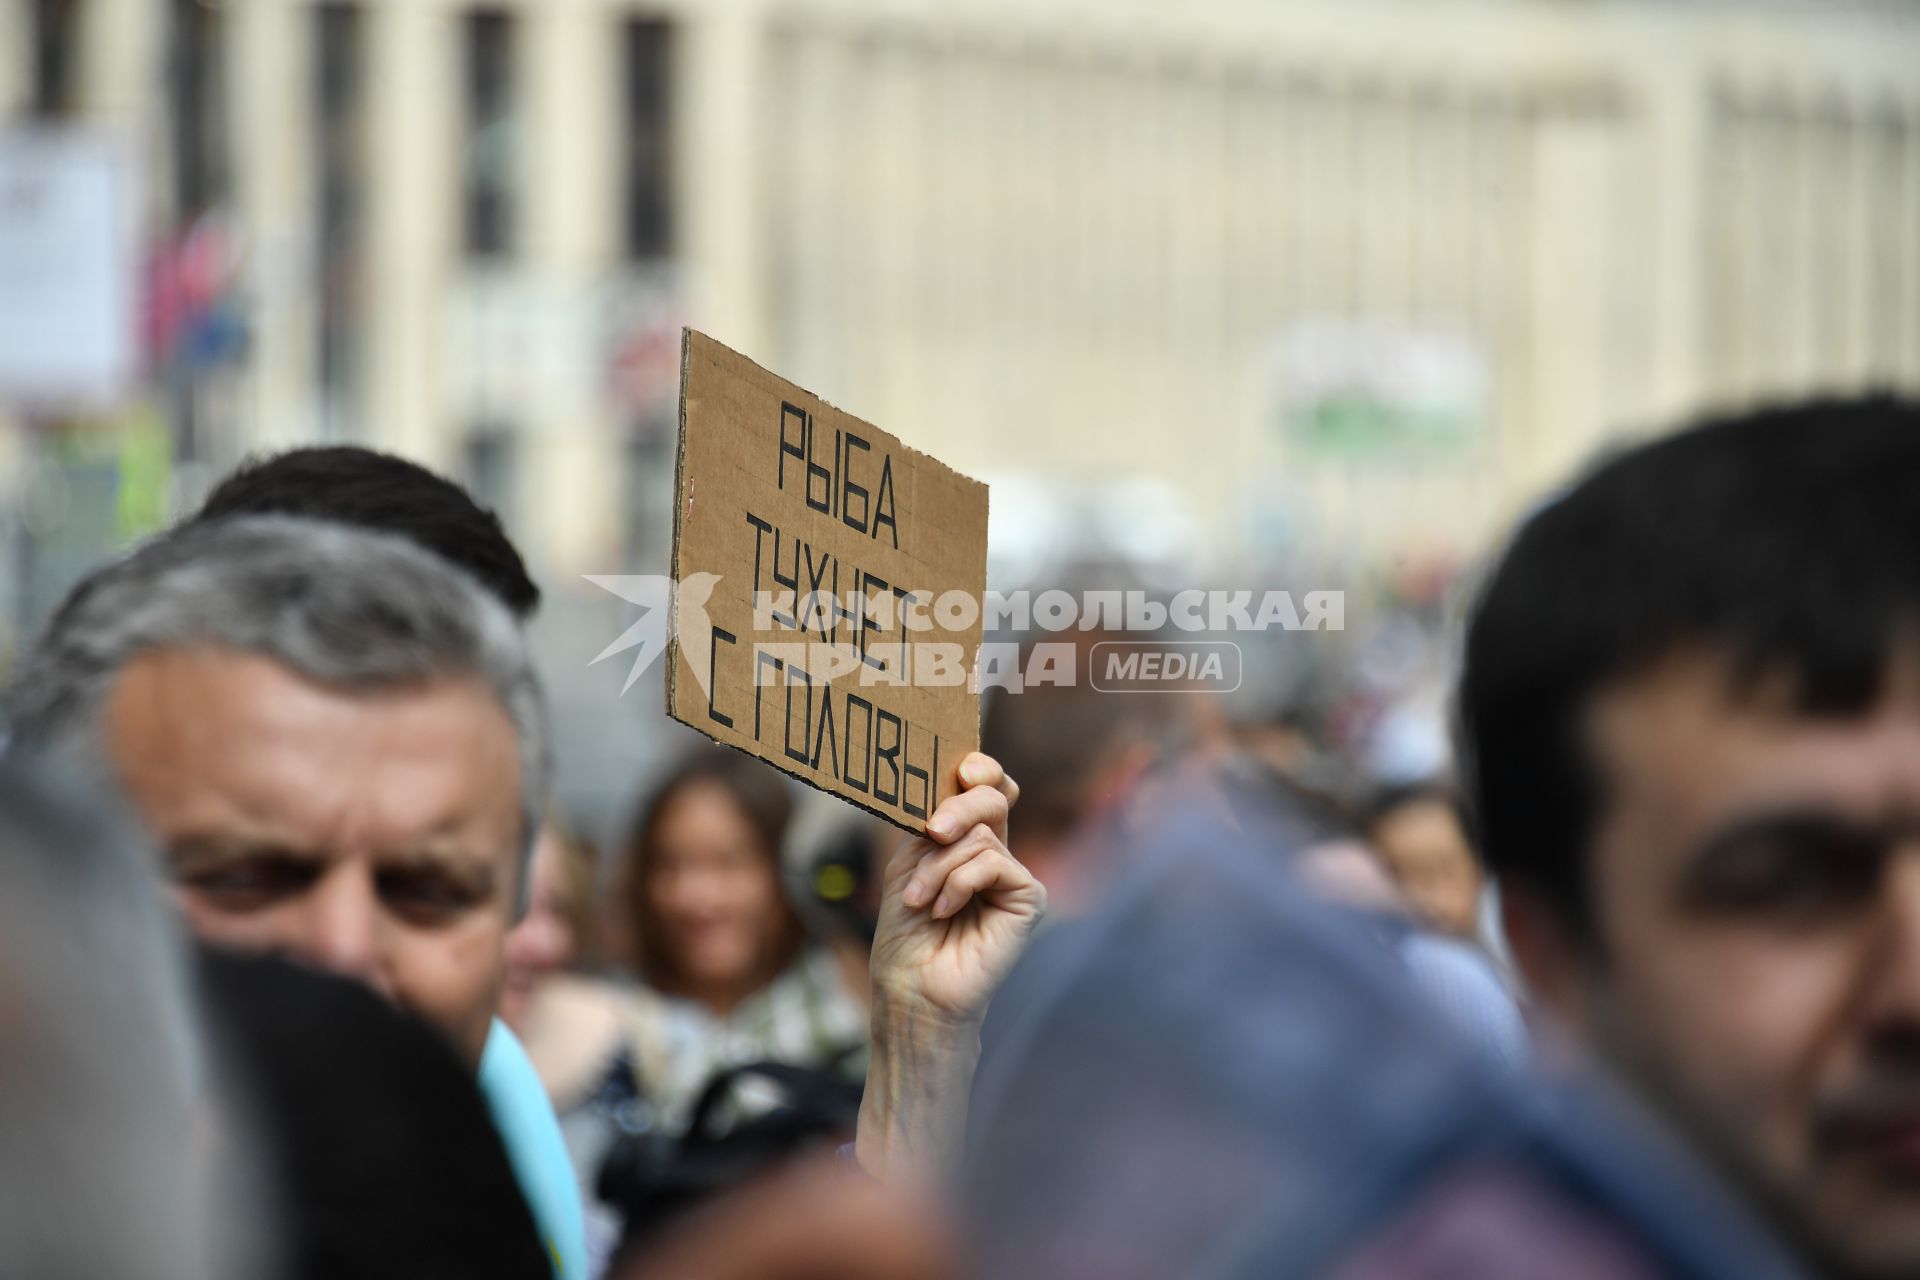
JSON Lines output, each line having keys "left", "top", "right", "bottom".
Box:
{"left": 1457, "top": 395, "right": 1920, "bottom": 929}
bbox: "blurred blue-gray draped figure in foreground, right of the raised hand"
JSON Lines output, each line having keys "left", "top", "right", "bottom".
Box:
{"left": 967, "top": 781, "right": 1801, "bottom": 1280}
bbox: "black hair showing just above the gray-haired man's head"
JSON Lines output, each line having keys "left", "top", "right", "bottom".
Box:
{"left": 194, "top": 445, "right": 540, "bottom": 622}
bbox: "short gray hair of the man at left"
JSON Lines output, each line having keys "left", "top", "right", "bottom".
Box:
{"left": 6, "top": 516, "right": 551, "bottom": 906}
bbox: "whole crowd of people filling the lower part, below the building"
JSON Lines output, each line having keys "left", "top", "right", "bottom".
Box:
{"left": 11, "top": 397, "right": 1920, "bottom": 1280}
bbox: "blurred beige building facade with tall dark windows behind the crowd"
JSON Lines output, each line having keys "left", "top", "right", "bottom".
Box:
{"left": 0, "top": 0, "right": 1920, "bottom": 821}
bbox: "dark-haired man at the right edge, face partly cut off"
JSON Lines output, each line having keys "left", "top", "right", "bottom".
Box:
{"left": 1459, "top": 399, "right": 1920, "bottom": 1278}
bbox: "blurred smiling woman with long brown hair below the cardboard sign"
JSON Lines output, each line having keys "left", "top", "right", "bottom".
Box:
{"left": 579, "top": 747, "right": 868, "bottom": 1257}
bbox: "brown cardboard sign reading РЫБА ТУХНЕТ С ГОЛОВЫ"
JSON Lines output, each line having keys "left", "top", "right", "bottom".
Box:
{"left": 666, "top": 330, "right": 987, "bottom": 833}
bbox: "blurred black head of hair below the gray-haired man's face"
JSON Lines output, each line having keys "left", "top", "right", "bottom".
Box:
{"left": 198, "top": 946, "right": 553, "bottom": 1280}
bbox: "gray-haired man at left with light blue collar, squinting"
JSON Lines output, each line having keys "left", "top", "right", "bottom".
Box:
{"left": 8, "top": 516, "right": 586, "bottom": 1278}
